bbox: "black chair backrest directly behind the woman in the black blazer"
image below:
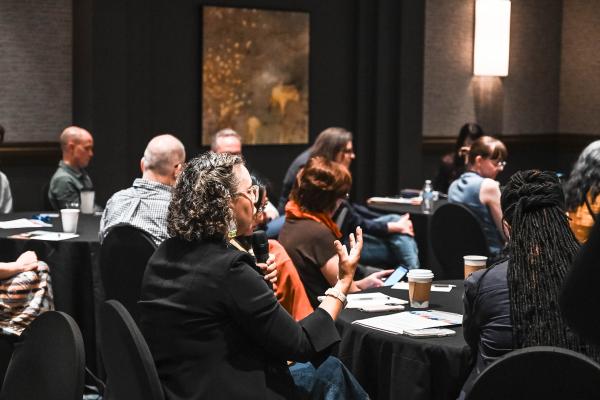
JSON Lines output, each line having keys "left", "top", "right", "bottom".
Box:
{"left": 100, "top": 300, "right": 164, "bottom": 400}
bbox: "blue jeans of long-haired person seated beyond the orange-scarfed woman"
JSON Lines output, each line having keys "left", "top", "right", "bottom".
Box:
{"left": 360, "top": 214, "right": 419, "bottom": 269}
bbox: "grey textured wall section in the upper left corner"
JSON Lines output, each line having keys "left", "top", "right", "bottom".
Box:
{"left": 0, "top": 0, "right": 73, "bottom": 142}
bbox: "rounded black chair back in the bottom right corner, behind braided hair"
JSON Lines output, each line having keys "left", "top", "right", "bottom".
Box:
{"left": 466, "top": 346, "right": 600, "bottom": 400}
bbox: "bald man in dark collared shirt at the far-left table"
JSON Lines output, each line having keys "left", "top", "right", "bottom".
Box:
{"left": 48, "top": 126, "right": 94, "bottom": 210}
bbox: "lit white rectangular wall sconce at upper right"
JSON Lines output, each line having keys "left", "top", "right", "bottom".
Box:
{"left": 473, "top": 0, "right": 510, "bottom": 76}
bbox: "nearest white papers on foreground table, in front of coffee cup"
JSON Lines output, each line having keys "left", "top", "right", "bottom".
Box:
{"left": 353, "top": 310, "right": 462, "bottom": 334}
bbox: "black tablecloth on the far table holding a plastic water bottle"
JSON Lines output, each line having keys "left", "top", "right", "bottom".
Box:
{"left": 369, "top": 200, "right": 447, "bottom": 276}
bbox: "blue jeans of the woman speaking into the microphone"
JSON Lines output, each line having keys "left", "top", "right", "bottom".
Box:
{"left": 290, "top": 357, "right": 369, "bottom": 400}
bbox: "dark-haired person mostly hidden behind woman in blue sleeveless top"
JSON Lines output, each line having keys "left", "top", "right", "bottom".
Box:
{"left": 433, "top": 122, "right": 484, "bottom": 193}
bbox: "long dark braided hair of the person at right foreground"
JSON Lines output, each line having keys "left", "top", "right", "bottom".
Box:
{"left": 500, "top": 170, "right": 600, "bottom": 360}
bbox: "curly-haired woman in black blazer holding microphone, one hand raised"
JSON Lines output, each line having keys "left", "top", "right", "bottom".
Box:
{"left": 139, "top": 152, "right": 366, "bottom": 400}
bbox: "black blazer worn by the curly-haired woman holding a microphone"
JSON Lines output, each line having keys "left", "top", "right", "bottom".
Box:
{"left": 140, "top": 238, "right": 339, "bottom": 400}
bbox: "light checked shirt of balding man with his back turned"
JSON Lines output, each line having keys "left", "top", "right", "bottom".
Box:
{"left": 100, "top": 178, "right": 171, "bottom": 246}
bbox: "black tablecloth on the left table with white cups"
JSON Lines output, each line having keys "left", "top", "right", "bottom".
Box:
{"left": 0, "top": 212, "right": 103, "bottom": 371}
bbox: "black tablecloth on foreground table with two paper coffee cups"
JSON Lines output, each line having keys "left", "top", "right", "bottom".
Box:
{"left": 336, "top": 281, "right": 471, "bottom": 400}
